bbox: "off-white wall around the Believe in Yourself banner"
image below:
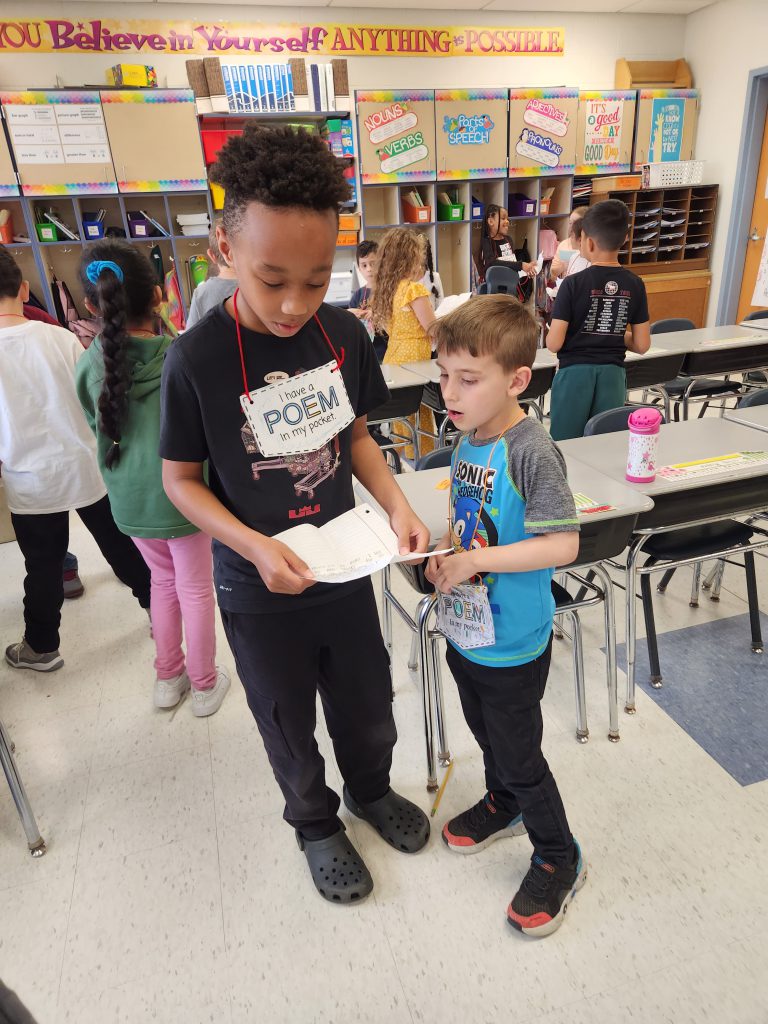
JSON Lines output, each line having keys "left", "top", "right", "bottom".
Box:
{"left": 0, "top": 0, "right": 685, "bottom": 89}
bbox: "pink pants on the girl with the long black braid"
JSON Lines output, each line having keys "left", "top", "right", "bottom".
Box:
{"left": 133, "top": 534, "right": 216, "bottom": 690}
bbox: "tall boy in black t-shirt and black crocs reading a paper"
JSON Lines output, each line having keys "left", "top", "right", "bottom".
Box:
{"left": 160, "top": 125, "right": 429, "bottom": 905}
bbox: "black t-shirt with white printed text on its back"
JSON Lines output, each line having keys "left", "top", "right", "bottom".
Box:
{"left": 552, "top": 266, "right": 648, "bottom": 369}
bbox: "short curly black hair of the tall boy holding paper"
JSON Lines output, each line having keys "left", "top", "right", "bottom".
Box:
{"left": 209, "top": 124, "right": 349, "bottom": 231}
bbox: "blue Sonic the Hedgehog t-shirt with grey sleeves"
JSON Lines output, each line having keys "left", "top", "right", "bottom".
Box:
{"left": 451, "top": 419, "right": 579, "bottom": 668}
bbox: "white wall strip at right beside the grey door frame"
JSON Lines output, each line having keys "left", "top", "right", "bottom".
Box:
{"left": 685, "top": 0, "right": 768, "bottom": 324}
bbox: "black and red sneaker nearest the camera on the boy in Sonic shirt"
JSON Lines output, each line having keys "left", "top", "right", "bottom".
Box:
{"left": 507, "top": 840, "right": 587, "bottom": 937}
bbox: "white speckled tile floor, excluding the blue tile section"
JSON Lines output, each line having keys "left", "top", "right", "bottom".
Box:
{"left": 0, "top": 516, "right": 768, "bottom": 1024}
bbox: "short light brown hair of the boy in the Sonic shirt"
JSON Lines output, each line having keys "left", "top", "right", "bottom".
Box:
{"left": 431, "top": 295, "right": 539, "bottom": 372}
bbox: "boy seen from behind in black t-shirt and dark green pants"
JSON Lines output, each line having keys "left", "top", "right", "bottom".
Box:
{"left": 547, "top": 199, "right": 650, "bottom": 441}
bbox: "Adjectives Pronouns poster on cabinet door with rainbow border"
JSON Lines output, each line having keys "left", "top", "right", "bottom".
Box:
{"left": 509, "top": 89, "right": 579, "bottom": 176}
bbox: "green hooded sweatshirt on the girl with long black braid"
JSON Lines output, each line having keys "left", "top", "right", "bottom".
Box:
{"left": 75, "top": 335, "right": 198, "bottom": 540}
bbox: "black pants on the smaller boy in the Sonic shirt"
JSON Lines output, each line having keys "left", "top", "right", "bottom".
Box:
{"left": 445, "top": 638, "right": 573, "bottom": 866}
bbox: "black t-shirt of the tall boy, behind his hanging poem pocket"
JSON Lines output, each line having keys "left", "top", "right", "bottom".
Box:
{"left": 160, "top": 303, "right": 389, "bottom": 612}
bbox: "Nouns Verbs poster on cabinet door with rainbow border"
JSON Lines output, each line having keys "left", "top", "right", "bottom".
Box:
{"left": 355, "top": 89, "right": 435, "bottom": 184}
